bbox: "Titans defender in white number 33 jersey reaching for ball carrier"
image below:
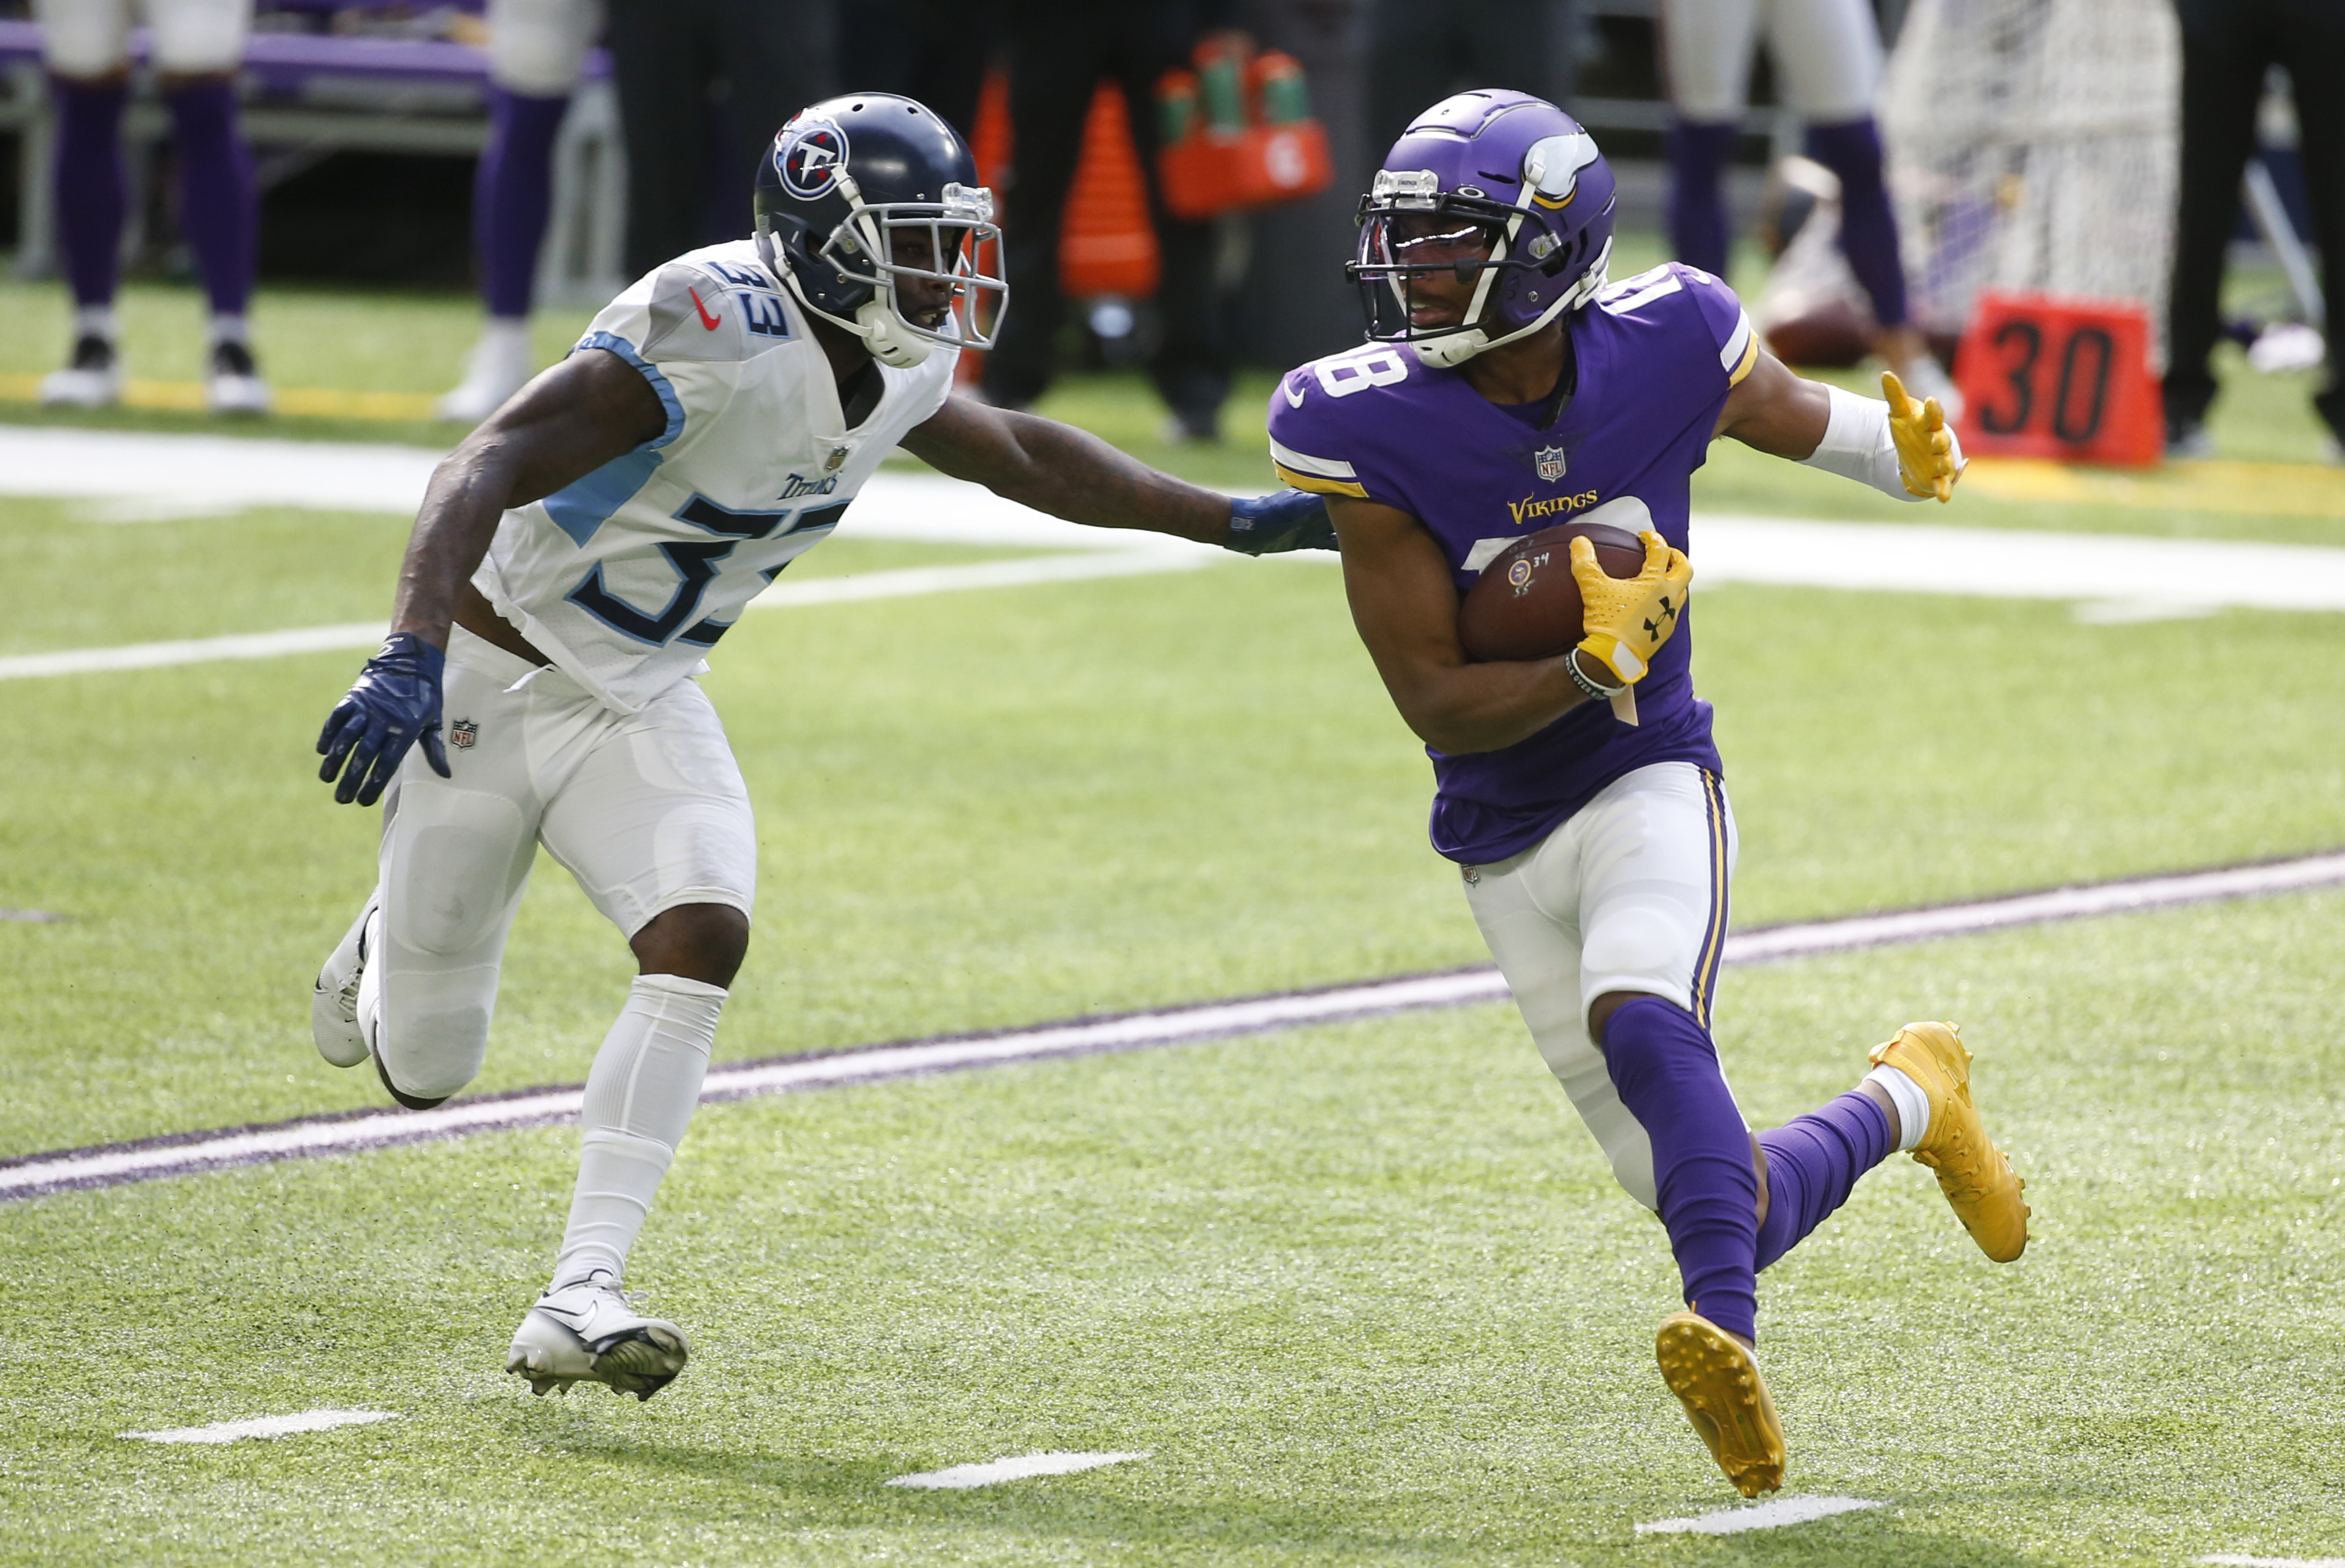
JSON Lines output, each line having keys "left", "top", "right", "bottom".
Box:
{"left": 312, "top": 94, "right": 1334, "bottom": 1399}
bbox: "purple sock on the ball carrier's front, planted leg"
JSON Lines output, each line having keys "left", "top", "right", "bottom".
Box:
{"left": 1604, "top": 996, "right": 1759, "bottom": 1338}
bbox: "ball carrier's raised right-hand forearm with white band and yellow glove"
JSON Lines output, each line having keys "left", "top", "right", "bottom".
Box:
{"left": 1717, "top": 349, "right": 1963, "bottom": 502}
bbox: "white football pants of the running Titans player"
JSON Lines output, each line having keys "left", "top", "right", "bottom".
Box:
{"left": 368, "top": 626, "right": 757, "bottom": 1099}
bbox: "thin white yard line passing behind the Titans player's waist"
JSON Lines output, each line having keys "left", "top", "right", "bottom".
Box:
{"left": 0, "top": 541, "right": 1224, "bottom": 680}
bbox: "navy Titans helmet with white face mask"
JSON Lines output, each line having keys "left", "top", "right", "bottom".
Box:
{"left": 755, "top": 92, "right": 1011, "bottom": 368}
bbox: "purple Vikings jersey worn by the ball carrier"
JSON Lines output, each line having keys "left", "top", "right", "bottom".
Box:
{"left": 1271, "top": 263, "right": 1759, "bottom": 865}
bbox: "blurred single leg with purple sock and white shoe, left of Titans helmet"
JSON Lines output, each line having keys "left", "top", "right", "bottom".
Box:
{"left": 436, "top": 0, "right": 603, "bottom": 424}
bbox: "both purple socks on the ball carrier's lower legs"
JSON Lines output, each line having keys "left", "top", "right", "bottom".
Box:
{"left": 1604, "top": 996, "right": 1890, "bottom": 1341}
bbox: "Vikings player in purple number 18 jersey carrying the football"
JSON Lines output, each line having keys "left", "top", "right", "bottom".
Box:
{"left": 1271, "top": 92, "right": 2028, "bottom": 1496}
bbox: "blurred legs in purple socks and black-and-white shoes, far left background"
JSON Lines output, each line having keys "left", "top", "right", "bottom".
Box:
{"left": 33, "top": 0, "right": 270, "bottom": 415}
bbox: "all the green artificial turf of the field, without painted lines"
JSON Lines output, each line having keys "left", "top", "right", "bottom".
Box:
{"left": 0, "top": 250, "right": 2345, "bottom": 1568}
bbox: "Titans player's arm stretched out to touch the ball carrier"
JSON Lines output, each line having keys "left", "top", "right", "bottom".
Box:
{"left": 903, "top": 396, "right": 1334, "bottom": 555}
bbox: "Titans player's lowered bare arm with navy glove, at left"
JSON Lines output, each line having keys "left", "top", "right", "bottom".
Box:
{"left": 317, "top": 349, "right": 668, "bottom": 806}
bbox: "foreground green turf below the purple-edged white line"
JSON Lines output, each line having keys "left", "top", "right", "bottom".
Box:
{"left": 0, "top": 896, "right": 2345, "bottom": 1568}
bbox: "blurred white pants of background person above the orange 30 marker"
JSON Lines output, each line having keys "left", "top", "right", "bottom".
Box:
{"left": 1658, "top": 0, "right": 1881, "bottom": 124}
